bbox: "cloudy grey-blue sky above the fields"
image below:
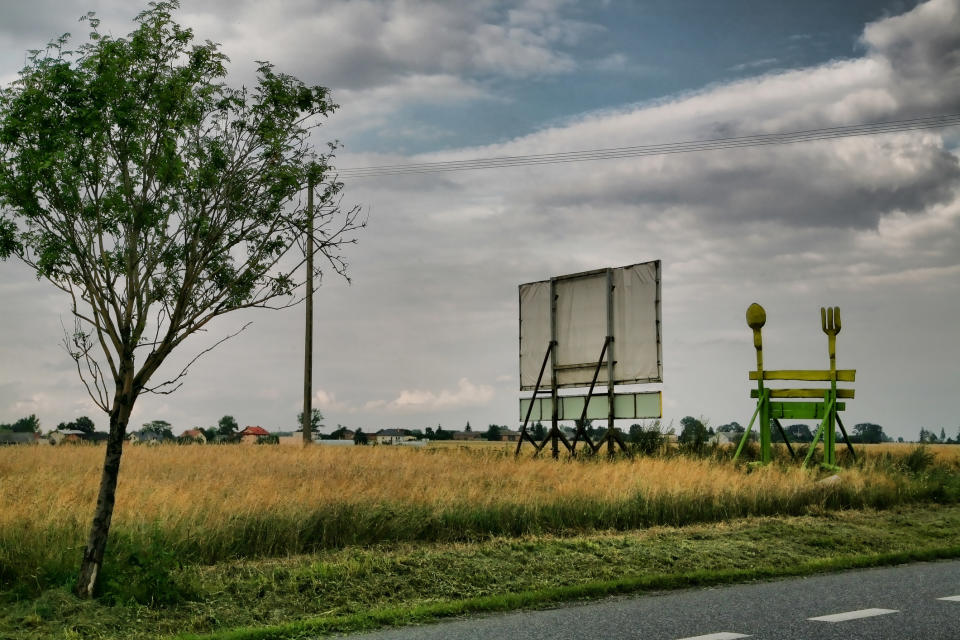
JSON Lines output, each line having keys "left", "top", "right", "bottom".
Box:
{"left": 0, "top": 0, "right": 960, "bottom": 439}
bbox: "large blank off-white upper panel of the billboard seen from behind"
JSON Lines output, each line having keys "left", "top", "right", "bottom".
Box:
{"left": 520, "top": 260, "right": 663, "bottom": 390}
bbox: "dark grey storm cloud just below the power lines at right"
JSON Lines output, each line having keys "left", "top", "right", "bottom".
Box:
{"left": 530, "top": 136, "right": 960, "bottom": 228}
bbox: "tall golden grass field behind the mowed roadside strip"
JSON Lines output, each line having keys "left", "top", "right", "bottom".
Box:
{"left": 0, "top": 445, "right": 948, "bottom": 578}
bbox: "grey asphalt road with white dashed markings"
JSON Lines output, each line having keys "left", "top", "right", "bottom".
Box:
{"left": 338, "top": 561, "right": 960, "bottom": 640}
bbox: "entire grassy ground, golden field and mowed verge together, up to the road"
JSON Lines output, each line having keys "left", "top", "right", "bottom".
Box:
{"left": 0, "top": 443, "right": 960, "bottom": 640}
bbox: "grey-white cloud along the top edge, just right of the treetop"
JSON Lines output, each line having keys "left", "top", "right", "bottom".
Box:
{"left": 182, "top": 0, "right": 601, "bottom": 90}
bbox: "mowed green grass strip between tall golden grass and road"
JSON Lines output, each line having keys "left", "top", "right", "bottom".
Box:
{"left": 0, "top": 505, "right": 960, "bottom": 640}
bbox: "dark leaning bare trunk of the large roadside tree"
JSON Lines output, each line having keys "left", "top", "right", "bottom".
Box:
{"left": 77, "top": 394, "right": 136, "bottom": 598}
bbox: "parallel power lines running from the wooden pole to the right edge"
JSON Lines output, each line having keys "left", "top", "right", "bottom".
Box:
{"left": 339, "top": 113, "right": 960, "bottom": 178}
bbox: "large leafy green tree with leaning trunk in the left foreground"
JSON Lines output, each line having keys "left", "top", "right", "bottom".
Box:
{"left": 0, "top": 0, "right": 363, "bottom": 597}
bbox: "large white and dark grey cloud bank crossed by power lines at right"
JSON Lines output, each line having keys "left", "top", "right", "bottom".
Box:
{"left": 358, "top": 0, "right": 960, "bottom": 235}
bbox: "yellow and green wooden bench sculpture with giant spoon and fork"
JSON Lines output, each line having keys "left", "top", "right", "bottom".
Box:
{"left": 733, "top": 302, "right": 857, "bottom": 467}
